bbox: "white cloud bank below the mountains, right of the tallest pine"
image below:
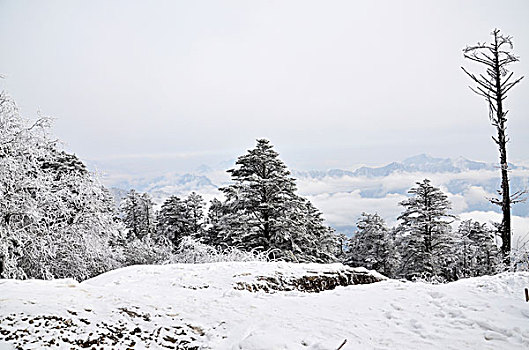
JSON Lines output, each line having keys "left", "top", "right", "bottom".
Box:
{"left": 297, "top": 170, "right": 529, "bottom": 230}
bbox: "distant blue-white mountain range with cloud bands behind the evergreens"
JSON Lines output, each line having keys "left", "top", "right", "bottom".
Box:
{"left": 103, "top": 154, "right": 529, "bottom": 228}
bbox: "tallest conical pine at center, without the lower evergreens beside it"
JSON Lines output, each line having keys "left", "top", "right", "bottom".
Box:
{"left": 220, "top": 140, "right": 300, "bottom": 254}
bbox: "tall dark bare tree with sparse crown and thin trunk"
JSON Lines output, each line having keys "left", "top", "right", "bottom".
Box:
{"left": 461, "top": 29, "right": 525, "bottom": 263}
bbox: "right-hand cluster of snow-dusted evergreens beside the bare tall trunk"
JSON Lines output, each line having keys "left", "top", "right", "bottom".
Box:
{"left": 344, "top": 179, "right": 506, "bottom": 281}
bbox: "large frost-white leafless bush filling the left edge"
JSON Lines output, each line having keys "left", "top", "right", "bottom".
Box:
{"left": 0, "top": 92, "right": 119, "bottom": 280}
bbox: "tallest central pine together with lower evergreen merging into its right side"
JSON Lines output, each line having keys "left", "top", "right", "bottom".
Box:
{"left": 213, "top": 139, "right": 337, "bottom": 261}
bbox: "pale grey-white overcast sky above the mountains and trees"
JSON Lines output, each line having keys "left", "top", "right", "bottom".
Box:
{"left": 0, "top": 0, "right": 529, "bottom": 170}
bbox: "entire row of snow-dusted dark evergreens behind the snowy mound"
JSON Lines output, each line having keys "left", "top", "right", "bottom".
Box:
{"left": 121, "top": 140, "right": 505, "bottom": 281}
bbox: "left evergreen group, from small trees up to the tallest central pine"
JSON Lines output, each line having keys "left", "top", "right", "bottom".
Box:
{"left": 120, "top": 139, "right": 339, "bottom": 263}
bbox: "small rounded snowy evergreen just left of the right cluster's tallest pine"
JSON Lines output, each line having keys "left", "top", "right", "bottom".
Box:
{"left": 347, "top": 213, "right": 399, "bottom": 277}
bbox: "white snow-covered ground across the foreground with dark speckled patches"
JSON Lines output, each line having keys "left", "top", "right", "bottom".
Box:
{"left": 0, "top": 262, "right": 529, "bottom": 350}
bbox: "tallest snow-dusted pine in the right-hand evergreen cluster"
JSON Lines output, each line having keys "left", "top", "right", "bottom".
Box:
{"left": 397, "top": 179, "right": 454, "bottom": 279}
